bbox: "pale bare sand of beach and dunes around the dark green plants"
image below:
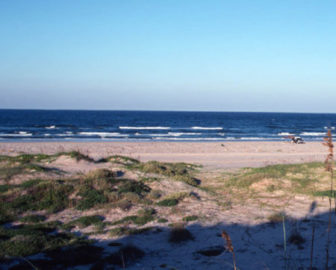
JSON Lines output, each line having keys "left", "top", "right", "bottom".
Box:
{"left": 0, "top": 142, "right": 336, "bottom": 270}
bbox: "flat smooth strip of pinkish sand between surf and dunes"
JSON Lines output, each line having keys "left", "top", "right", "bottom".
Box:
{"left": 0, "top": 142, "right": 327, "bottom": 168}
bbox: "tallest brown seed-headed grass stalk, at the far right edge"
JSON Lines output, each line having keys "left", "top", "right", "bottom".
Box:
{"left": 323, "top": 129, "right": 335, "bottom": 270}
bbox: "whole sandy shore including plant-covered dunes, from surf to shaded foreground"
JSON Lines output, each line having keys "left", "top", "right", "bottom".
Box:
{"left": 0, "top": 142, "right": 336, "bottom": 270}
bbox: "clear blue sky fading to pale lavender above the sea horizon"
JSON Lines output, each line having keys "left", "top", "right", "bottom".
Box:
{"left": 0, "top": 0, "right": 336, "bottom": 112}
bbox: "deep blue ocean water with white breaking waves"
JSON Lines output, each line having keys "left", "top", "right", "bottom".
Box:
{"left": 0, "top": 110, "right": 336, "bottom": 142}
